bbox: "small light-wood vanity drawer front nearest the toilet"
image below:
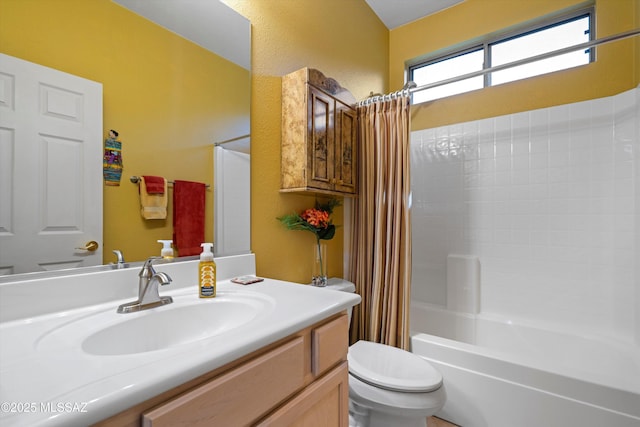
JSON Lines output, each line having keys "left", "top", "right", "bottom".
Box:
{"left": 311, "top": 314, "right": 349, "bottom": 376}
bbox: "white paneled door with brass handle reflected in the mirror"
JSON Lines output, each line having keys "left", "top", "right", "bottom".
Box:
{"left": 0, "top": 54, "right": 102, "bottom": 275}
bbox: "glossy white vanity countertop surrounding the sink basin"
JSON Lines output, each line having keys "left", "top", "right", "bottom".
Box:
{"left": 0, "top": 260, "right": 360, "bottom": 426}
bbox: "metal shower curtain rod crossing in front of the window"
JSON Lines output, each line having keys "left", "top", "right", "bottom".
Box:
{"left": 357, "top": 28, "right": 640, "bottom": 106}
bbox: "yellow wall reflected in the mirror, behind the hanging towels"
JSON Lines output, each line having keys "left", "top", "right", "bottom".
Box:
{"left": 0, "top": 0, "right": 250, "bottom": 262}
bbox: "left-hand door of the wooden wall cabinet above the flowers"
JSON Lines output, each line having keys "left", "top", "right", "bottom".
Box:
{"left": 307, "top": 86, "right": 335, "bottom": 190}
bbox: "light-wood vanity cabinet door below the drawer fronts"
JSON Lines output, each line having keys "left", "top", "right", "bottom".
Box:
{"left": 257, "top": 362, "right": 349, "bottom": 427}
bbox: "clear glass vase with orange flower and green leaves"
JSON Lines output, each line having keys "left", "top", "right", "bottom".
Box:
{"left": 277, "top": 199, "right": 340, "bottom": 286}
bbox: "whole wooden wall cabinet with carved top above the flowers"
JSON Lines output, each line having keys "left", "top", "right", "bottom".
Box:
{"left": 280, "top": 68, "right": 358, "bottom": 196}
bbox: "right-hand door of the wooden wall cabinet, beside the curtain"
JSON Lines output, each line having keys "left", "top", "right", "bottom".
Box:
{"left": 334, "top": 101, "right": 358, "bottom": 194}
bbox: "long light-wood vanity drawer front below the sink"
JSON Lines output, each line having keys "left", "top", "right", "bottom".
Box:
{"left": 142, "top": 337, "right": 304, "bottom": 427}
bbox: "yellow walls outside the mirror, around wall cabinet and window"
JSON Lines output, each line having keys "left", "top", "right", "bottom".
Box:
{"left": 225, "top": 0, "right": 640, "bottom": 282}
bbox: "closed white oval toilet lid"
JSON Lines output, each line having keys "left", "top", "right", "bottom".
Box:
{"left": 347, "top": 341, "right": 442, "bottom": 393}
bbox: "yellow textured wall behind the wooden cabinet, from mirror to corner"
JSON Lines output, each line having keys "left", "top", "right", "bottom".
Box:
{"left": 225, "top": 0, "right": 388, "bottom": 283}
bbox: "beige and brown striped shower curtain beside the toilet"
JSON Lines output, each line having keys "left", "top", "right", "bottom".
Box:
{"left": 350, "top": 96, "right": 411, "bottom": 349}
